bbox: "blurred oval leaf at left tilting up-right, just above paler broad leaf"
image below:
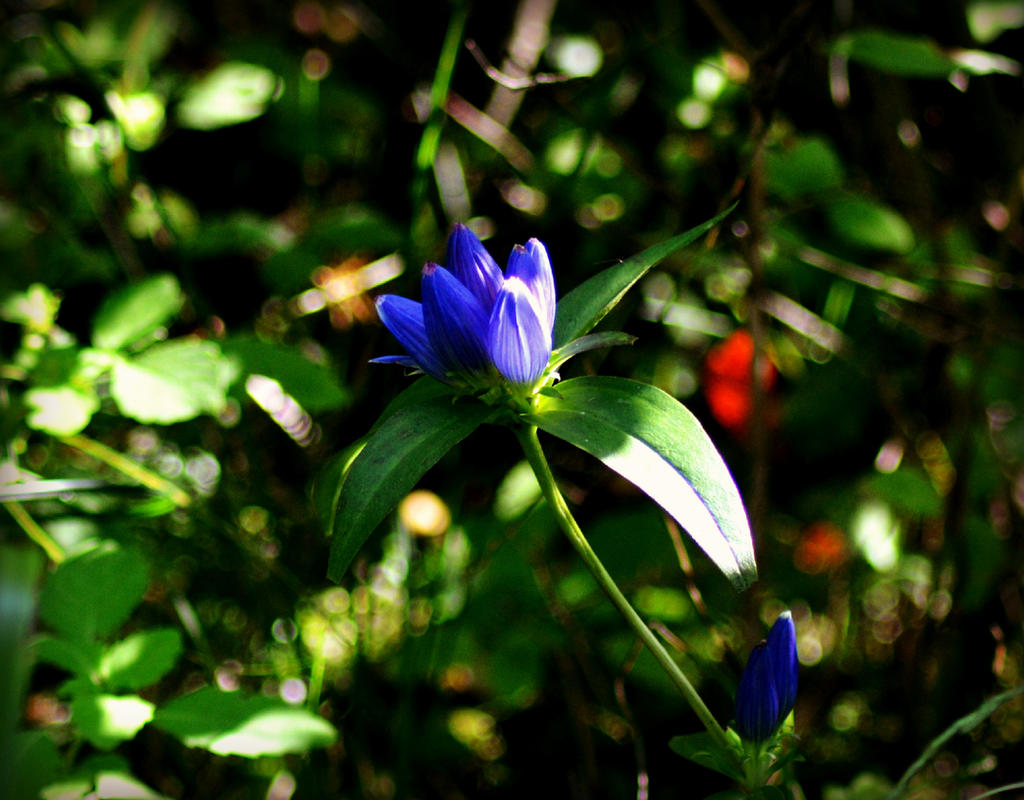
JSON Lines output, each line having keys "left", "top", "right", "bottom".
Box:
{"left": 92, "top": 273, "right": 184, "bottom": 350}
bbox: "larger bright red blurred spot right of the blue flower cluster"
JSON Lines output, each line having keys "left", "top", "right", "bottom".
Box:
{"left": 703, "top": 329, "right": 776, "bottom": 436}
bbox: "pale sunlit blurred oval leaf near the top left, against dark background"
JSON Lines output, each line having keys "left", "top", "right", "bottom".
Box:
{"left": 177, "top": 61, "right": 281, "bottom": 130}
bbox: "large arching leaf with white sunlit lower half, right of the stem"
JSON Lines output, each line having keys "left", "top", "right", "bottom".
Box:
{"left": 530, "top": 377, "right": 757, "bottom": 590}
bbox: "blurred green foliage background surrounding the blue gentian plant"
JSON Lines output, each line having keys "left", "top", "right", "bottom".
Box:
{"left": 0, "top": 0, "right": 1024, "bottom": 800}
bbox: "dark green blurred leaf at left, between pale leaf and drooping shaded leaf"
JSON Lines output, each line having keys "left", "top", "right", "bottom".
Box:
{"left": 220, "top": 336, "right": 348, "bottom": 414}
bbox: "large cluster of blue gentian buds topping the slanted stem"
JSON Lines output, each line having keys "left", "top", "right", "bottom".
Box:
{"left": 373, "top": 224, "right": 555, "bottom": 393}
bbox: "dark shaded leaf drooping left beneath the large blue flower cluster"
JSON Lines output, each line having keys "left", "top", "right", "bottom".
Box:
{"left": 328, "top": 396, "right": 495, "bottom": 581}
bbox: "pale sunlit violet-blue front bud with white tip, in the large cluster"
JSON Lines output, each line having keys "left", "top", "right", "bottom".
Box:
{"left": 487, "top": 278, "right": 551, "bottom": 385}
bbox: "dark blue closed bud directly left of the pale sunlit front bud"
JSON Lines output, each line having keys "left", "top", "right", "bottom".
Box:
{"left": 423, "top": 264, "right": 488, "bottom": 377}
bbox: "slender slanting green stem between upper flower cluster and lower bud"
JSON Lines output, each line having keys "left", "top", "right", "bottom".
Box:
{"left": 515, "top": 425, "right": 732, "bottom": 753}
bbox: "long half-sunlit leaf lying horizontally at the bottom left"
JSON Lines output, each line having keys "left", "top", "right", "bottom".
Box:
{"left": 153, "top": 686, "right": 338, "bottom": 758}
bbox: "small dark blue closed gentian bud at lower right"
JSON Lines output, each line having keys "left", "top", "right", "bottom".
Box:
{"left": 736, "top": 612, "right": 797, "bottom": 743}
